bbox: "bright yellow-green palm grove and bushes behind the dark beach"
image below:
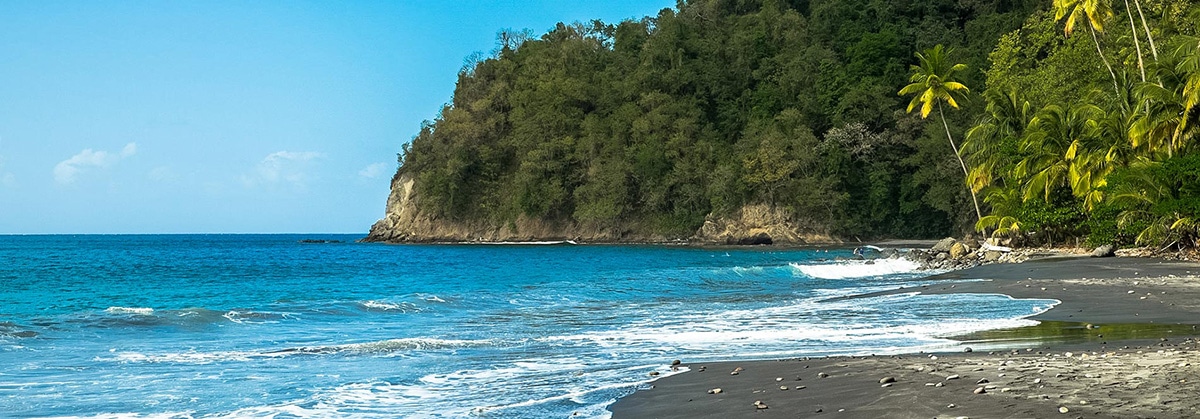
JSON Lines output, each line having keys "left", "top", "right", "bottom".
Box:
{"left": 964, "top": 0, "right": 1200, "bottom": 247}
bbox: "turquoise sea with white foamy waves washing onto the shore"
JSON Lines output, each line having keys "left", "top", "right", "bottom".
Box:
{"left": 0, "top": 234, "right": 1055, "bottom": 419}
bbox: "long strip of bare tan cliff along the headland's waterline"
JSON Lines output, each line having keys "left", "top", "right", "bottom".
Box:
{"left": 365, "top": 174, "right": 839, "bottom": 245}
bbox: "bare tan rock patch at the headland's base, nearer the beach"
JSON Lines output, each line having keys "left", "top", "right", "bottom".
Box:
{"left": 692, "top": 204, "right": 841, "bottom": 245}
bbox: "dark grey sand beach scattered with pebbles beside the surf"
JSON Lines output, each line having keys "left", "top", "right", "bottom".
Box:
{"left": 611, "top": 257, "right": 1200, "bottom": 419}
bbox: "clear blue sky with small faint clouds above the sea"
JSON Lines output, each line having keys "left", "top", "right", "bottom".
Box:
{"left": 0, "top": 0, "right": 674, "bottom": 234}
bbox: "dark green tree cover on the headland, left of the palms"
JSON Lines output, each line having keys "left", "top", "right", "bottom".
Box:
{"left": 400, "top": 0, "right": 1043, "bottom": 237}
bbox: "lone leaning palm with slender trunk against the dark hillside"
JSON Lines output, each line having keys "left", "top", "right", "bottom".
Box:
{"left": 900, "top": 44, "right": 983, "bottom": 220}
